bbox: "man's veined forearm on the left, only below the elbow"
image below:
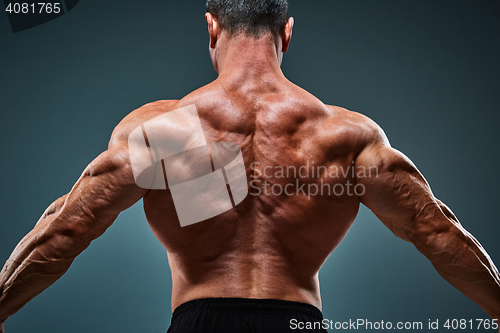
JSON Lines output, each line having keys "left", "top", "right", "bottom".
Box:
{"left": 0, "top": 184, "right": 118, "bottom": 322}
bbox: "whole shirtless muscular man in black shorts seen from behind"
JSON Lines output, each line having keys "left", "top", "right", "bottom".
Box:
{"left": 0, "top": 1, "right": 500, "bottom": 333}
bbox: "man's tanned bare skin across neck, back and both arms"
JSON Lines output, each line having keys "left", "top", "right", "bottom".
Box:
{"left": 0, "top": 14, "right": 500, "bottom": 332}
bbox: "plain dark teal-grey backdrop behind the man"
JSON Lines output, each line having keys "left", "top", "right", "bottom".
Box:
{"left": 0, "top": 0, "right": 500, "bottom": 333}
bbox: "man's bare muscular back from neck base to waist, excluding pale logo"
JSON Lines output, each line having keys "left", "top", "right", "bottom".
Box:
{"left": 132, "top": 76, "right": 363, "bottom": 308}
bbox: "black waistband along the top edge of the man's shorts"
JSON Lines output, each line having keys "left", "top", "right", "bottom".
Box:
{"left": 173, "top": 298, "right": 323, "bottom": 321}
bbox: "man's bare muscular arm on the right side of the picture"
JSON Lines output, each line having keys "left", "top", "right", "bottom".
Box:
{"left": 355, "top": 119, "right": 500, "bottom": 320}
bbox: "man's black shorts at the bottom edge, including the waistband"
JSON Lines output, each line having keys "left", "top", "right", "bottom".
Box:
{"left": 167, "top": 298, "right": 327, "bottom": 333}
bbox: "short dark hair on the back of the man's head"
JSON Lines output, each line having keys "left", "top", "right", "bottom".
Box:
{"left": 207, "top": 0, "right": 288, "bottom": 37}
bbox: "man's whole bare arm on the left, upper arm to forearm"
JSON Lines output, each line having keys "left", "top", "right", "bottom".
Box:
{"left": 0, "top": 131, "right": 147, "bottom": 333}
